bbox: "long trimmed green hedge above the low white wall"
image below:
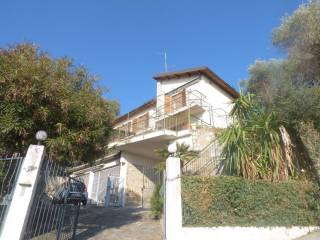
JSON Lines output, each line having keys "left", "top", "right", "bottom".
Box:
{"left": 182, "top": 176, "right": 320, "bottom": 226}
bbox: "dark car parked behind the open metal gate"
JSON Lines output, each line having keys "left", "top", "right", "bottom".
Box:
{"left": 52, "top": 179, "right": 88, "bottom": 205}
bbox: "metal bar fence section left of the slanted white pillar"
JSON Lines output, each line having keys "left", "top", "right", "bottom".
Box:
{"left": 0, "top": 154, "right": 23, "bottom": 231}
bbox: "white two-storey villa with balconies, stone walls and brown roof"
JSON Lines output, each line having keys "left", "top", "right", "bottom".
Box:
{"left": 74, "top": 67, "right": 238, "bottom": 207}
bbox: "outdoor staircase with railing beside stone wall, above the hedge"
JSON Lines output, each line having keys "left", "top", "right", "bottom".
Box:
{"left": 182, "top": 139, "right": 221, "bottom": 176}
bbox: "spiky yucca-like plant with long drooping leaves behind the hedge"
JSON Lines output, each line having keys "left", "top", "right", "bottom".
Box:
{"left": 219, "top": 93, "right": 294, "bottom": 180}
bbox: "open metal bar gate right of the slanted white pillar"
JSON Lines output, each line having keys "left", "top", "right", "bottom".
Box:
{"left": 24, "top": 159, "right": 80, "bottom": 240}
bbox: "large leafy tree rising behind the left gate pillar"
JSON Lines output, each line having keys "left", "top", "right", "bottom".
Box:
{"left": 0, "top": 44, "right": 118, "bottom": 164}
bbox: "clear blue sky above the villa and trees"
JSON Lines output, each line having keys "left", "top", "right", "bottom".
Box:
{"left": 0, "top": 0, "right": 306, "bottom": 113}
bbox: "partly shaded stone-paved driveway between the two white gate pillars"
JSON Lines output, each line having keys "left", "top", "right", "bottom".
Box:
{"left": 76, "top": 205, "right": 162, "bottom": 240}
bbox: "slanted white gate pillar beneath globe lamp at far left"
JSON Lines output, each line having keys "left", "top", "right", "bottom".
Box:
{"left": 0, "top": 145, "right": 44, "bottom": 240}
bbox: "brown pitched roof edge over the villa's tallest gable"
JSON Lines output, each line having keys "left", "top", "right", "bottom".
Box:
{"left": 153, "top": 67, "right": 239, "bottom": 98}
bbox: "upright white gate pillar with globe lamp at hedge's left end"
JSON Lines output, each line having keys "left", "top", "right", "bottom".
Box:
{"left": 165, "top": 143, "right": 182, "bottom": 240}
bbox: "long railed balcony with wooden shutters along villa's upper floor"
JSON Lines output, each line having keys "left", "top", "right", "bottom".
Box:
{"left": 111, "top": 89, "right": 209, "bottom": 144}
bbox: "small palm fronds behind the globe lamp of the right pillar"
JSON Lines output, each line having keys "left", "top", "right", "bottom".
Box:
{"left": 156, "top": 143, "right": 199, "bottom": 171}
